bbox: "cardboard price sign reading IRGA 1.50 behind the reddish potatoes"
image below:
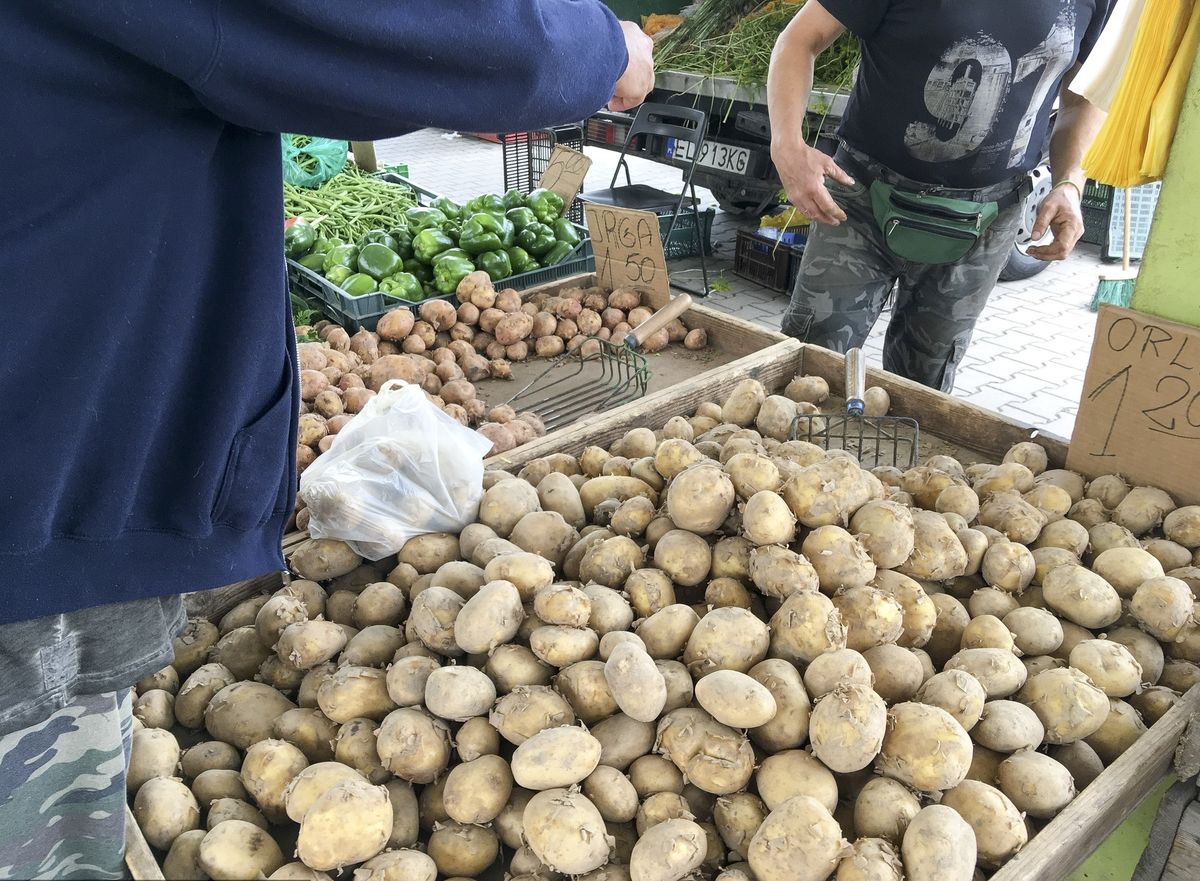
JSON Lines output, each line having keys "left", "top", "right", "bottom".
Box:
{"left": 583, "top": 203, "right": 671, "bottom": 308}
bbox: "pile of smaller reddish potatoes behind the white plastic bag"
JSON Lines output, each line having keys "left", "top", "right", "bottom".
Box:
{"left": 296, "top": 272, "right": 708, "bottom": 472}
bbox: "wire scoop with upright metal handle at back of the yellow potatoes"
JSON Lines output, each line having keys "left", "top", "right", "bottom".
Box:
{"left": 792, "top": 348, "right": 920, "bottom": 469}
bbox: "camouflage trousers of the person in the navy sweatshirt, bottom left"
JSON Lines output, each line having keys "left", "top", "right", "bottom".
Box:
{"left": 0, "top": 689, "right": 132, "bottom": 879}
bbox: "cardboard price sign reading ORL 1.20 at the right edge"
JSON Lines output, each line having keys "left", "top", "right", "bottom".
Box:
{"left": 1067, "top": 306, "right": 1200, "bottom": 504}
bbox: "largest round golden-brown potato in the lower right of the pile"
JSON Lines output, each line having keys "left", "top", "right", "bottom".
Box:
{"left": 878, "top": 705, "right": 969, "bottom": 792}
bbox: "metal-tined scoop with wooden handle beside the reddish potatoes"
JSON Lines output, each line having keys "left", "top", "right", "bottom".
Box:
{"left": 508, "top": 294, "right": 691, "bottom": 430}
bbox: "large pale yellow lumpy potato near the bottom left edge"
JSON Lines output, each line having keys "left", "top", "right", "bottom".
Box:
{"left": 296, "top": 782, "right": 391, "bottom": 871}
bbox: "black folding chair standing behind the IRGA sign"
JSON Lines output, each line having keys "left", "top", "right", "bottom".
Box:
{"left": 580, "top": 104, "right": 709, "bottom": 296}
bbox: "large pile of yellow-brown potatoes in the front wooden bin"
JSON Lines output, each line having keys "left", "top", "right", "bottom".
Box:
{"left": 128, "top": 378, "right": 1200, "bottom": 881}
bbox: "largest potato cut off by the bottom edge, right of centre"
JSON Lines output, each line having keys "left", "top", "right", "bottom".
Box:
{"left": 745, "top": 796, "right": 849, "bottom": 881}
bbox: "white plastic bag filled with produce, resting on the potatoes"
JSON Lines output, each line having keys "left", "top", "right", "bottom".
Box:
{"left": 300, "top": 380, "right": 492, "bottom": 559}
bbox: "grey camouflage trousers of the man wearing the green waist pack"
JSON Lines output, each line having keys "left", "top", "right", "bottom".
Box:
{"left": 782, "top": 148, "right": 1022, "bottom": 391}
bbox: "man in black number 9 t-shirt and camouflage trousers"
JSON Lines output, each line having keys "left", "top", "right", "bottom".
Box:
{"left": 767, "top": 0, "right": 1114, "bottom": 391}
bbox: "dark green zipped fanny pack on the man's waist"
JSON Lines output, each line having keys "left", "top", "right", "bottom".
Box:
{"left": 871, "top": 180, "right": 1000, "bottom": 265}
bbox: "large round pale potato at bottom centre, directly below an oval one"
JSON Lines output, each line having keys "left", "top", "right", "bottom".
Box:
{"left": 522, "top": 789, "right": 612, "bottom": 875}
